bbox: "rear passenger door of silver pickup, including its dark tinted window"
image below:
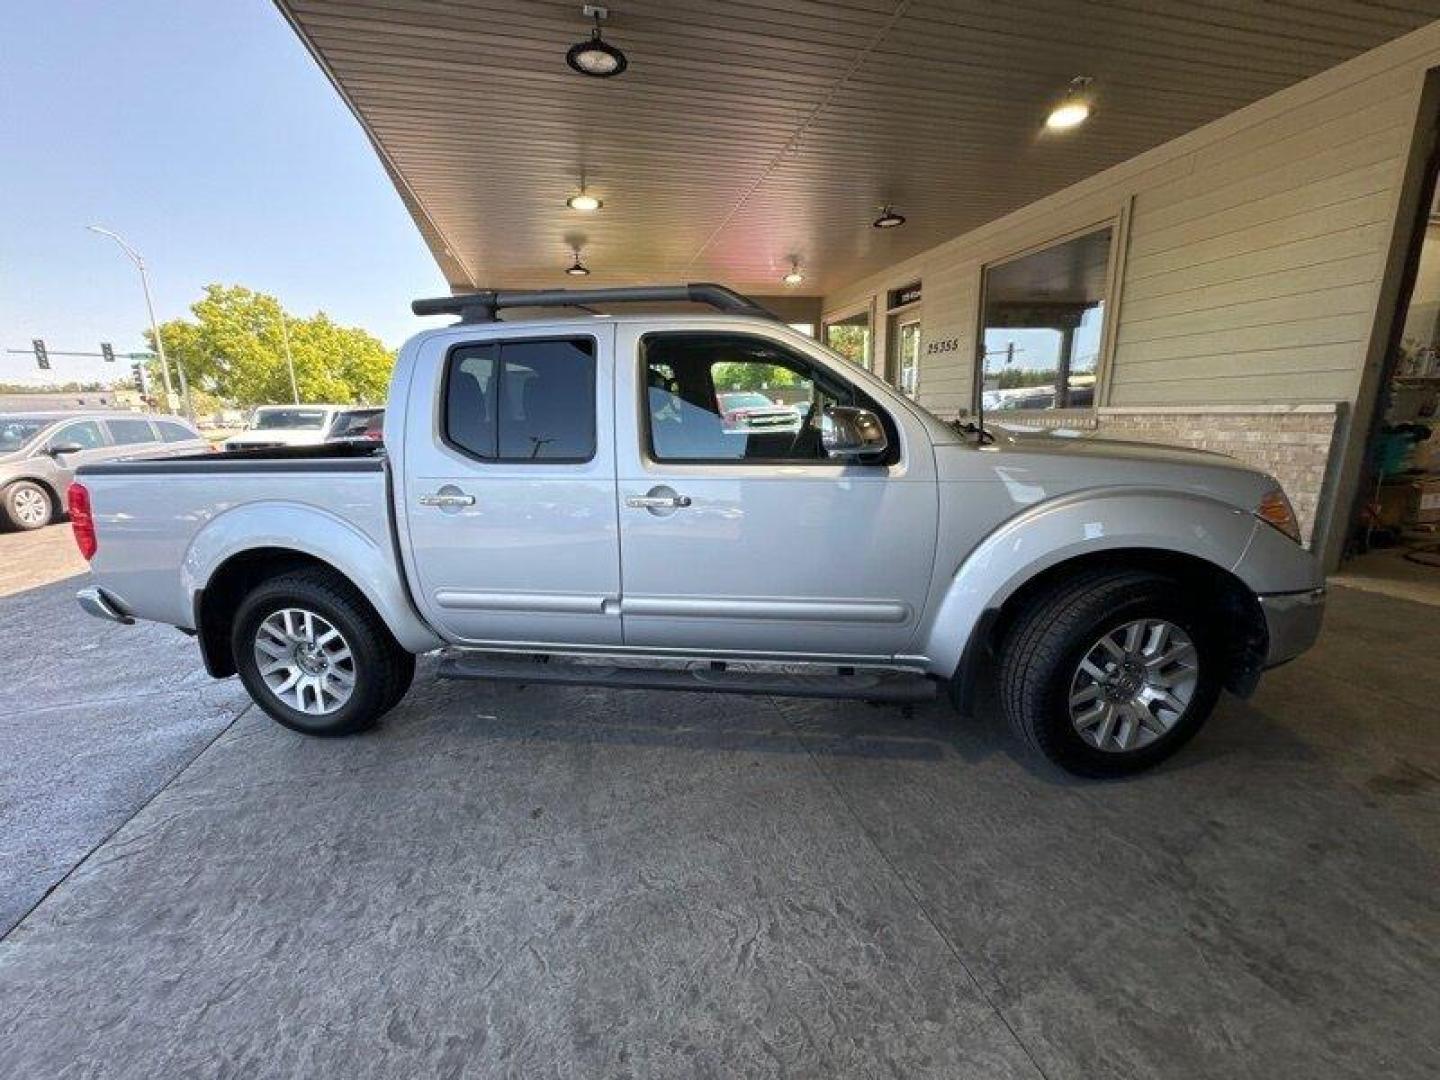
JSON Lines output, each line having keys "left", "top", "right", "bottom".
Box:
{"left": 397, "top": 321, "right": 621, "bottom": 647}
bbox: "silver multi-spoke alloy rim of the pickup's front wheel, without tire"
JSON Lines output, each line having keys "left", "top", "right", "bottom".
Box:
{"left": 1068, "top": 619, "right": 1200, "bottom": 753}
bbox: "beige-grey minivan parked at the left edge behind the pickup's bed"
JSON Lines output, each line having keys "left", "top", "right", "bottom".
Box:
{"left": 0, "top": 412, "right": 210, "bottom": 528}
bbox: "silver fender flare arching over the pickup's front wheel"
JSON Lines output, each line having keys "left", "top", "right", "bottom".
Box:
{"left": 917, "top": 488, "right": 1255, "bottom": 677}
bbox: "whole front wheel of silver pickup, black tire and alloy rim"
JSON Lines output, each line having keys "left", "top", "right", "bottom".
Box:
{"left": 999, "top": 570, "right": 1224, "bottom": 778}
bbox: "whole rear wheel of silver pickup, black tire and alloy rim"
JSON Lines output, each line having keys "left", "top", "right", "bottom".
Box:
{"left": 230, "top": 567, "right": 415, "bottom": 736}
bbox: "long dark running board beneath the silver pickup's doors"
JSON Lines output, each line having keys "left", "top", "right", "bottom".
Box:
{"left": 439, "top": 655, "right": 936, "bottom": 704}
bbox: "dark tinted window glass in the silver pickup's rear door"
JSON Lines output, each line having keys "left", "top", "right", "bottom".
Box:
{"left": 445, "top": 337, "right": 595, "bottom": 462}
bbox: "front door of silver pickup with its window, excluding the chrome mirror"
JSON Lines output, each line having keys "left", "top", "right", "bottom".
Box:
{"left": 616, "top": 324, "right": 937, "bottom": 658}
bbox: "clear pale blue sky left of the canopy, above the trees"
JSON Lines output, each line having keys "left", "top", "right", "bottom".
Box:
{"left": 0, "top": 0, "right": 449, "bottom": 382}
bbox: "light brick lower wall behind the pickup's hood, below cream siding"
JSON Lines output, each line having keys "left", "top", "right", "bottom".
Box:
{"left": 1096, "top": 405, "right": 1341, "bottom": 541}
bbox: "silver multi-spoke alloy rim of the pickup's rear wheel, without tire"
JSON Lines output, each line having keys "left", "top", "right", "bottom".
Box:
{"left": 255, "top": 608, "right": 356, "bottom": 716}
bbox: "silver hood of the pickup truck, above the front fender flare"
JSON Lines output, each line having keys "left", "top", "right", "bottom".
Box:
{"left": 935, "top": 431, "right": 1277, "bottom": 511}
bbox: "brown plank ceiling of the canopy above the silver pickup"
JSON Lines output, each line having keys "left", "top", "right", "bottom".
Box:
{"left": 278, "top": 0, "right": 1440, "bottom": 294}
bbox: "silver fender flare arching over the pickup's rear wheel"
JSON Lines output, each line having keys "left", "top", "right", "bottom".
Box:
{"left": 180, "top": 501, "right": 444, "bottom": 652}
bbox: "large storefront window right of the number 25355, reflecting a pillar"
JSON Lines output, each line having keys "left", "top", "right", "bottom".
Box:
{"left": 981, "top": 226, "right": 1115, "bottom": 412}
